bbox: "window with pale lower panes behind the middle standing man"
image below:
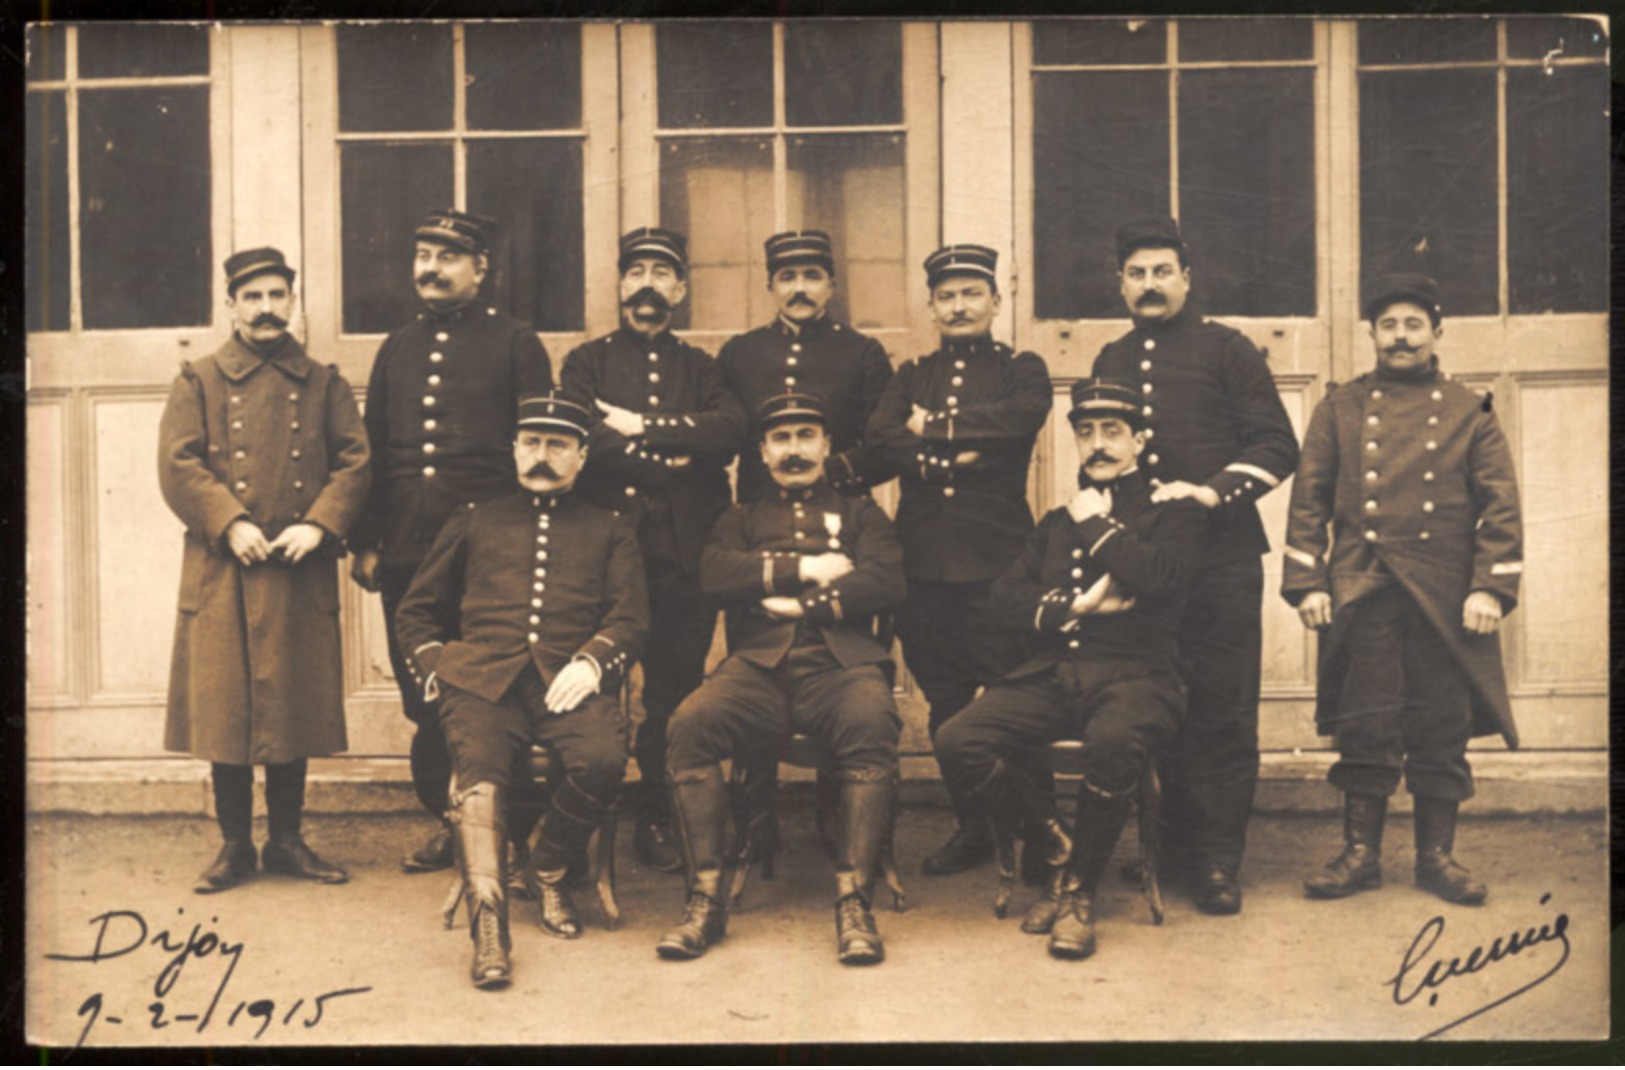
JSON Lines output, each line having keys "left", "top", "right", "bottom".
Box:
{"left": 655, "top": 21, "right": 907, "bottom": 330}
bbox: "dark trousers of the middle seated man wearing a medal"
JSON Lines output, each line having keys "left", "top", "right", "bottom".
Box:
{"left": 666, "top": 642, "right": 902, "bottom": 781}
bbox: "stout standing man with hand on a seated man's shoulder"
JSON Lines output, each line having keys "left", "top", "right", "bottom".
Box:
{"left": 1094, "top": 216, "right": 1298, "bottom": 914}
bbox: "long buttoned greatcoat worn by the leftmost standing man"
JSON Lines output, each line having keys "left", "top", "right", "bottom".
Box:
{"left": 158, "top": 335, "right": 371, "bottom": 764}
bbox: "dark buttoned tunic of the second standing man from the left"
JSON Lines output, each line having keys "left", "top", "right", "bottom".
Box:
{"left": 351, "top": 302, "right": 553, "bottom": 565}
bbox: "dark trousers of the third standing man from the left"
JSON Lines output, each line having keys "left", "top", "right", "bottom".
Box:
{"left": 632, "top": 576, "right": 717, "bottom": 803}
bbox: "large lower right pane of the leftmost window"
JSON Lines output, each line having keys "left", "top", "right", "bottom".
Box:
{"left": 80, "top": 86, "right": 218, "bottom": 328}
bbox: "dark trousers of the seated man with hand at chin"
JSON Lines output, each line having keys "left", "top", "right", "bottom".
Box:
{"left": 936, "top": 659, "right": 1185, "bottom": 795}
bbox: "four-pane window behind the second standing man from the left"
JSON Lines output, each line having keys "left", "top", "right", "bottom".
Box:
{"left": 336, "top": 23, "right": 585, "bottom": 333}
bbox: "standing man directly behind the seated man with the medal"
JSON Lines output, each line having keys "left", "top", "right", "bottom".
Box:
{"left": 717, "top": 231, "right": 892, "bottom": 504}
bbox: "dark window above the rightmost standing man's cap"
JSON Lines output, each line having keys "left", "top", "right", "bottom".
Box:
{"left": 1359, "top": 18, "right": 1609, "bottom": 315}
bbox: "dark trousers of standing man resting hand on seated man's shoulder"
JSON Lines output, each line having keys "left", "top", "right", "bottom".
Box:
{"left": 1162, "top": 558, "right": 1264, "bottom": 872}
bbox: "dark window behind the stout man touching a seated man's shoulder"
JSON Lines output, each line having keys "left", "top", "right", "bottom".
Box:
{"left": 1032, "top": 18, "right": 1315, "bottom": 319}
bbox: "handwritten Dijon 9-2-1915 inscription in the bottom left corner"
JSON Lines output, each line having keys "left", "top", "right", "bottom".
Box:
{"left": 46, "top": 907, "right": 372, "bottom": 1050}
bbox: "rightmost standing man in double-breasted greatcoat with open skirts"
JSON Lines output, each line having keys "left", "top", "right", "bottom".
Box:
{"left": 1281, "top": 275, "right": 1523, "bottom": 906}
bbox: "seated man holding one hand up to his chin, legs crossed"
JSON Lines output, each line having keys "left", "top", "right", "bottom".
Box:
{"left": 936, "top": 379, "right": 1206, "bottom": 958}
